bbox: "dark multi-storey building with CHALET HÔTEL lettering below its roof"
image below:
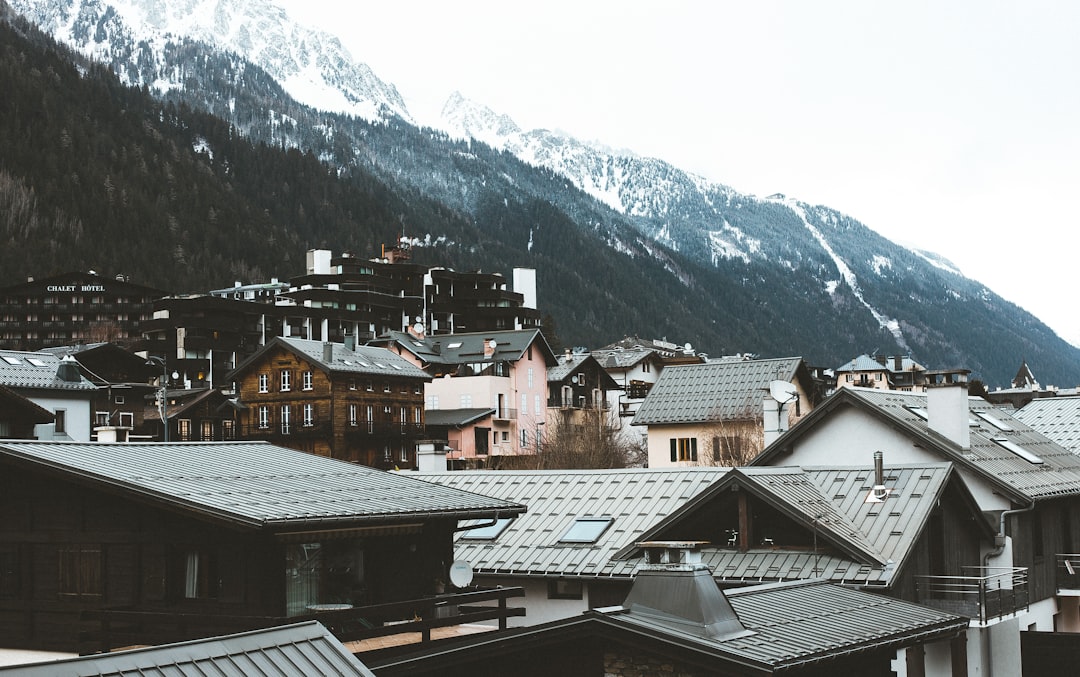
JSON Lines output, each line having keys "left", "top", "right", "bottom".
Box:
{"left": 0, "top": 272, "right": 167, "bottom": 351}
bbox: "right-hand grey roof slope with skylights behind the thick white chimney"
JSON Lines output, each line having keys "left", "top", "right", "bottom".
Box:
{"left": 842, "top": 388, "right": 1080, "bottom": 499}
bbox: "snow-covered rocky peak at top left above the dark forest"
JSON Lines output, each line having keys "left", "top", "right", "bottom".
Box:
{"left": 10, "top": 0, "right": 411, "bottom": 121}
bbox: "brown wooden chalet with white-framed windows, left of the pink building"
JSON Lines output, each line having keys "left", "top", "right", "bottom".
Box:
{"left": 229, "top": 337, "right": 431, "bottom": 469}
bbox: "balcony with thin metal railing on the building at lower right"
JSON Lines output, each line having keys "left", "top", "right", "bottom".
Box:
{"left": 915, "top": 567, "right": 1028, "bottom": 625}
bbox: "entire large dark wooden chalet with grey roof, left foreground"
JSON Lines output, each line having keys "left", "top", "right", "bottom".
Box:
{"left": 0, "top": 441, "right": 525, "bottom": 652}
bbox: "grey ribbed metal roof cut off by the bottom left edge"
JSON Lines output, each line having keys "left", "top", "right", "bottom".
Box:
{"left": 0, "top": 621, "right": 375, "bottom": 677}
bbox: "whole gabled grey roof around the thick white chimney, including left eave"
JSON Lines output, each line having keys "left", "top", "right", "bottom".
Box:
{"left": 752, "top": 388, "right": 1080, "bottom": 501}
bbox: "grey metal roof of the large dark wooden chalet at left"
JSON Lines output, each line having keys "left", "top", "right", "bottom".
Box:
{"left": 0, "top": 441, "right": 525, "bottom": 530}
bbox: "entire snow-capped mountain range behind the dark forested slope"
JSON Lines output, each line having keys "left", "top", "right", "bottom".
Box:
{"left": 8, "top": 0, "right": 1080, "bottom": 383}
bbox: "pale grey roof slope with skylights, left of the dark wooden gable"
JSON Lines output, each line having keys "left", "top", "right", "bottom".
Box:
{"left": 419, "top": 468, "right": 728, "bottom": 578}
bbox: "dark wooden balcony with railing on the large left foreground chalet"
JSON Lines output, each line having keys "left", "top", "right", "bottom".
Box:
{"left": 80, "top": 587, "right": 525, "bottom": 654}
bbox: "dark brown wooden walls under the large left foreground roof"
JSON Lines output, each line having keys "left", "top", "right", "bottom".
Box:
{"left": 0, "top": 462, "right": 457, "bottom": 651}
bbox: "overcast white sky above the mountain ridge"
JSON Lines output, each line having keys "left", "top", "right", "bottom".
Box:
{"left": 282, "top": 0, "right": 1080, "bottom": 349}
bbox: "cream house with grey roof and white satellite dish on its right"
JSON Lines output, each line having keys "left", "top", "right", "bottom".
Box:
{"left": 631, "top": 357, "right": 818, "bottom": 468}
